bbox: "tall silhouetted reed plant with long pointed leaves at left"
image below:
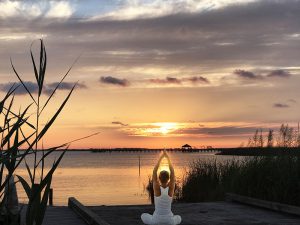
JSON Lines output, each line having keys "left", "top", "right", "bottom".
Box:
{"left": 0, "top": 40, "right": 76, "bottom": 225}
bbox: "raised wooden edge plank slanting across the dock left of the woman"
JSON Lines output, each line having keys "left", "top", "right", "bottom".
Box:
{"left": 68, "top": 197, "right": 110, "bottom": 225}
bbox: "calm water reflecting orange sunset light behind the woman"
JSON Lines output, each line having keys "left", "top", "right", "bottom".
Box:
{"left": 17, "top": 151, "right": 237, "bottom": 205}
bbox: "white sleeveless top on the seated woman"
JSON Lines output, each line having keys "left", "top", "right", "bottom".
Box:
{"left": 154, "top": 186, "right": 173, "bottom": 216}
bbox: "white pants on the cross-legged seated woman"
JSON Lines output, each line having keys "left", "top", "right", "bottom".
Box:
{"left": 141, "top": 213, "right": 181, "bottom": 225}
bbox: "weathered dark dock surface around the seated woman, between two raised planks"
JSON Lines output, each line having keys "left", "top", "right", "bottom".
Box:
{"left": 88, "top": 202, "right": 300, "bottom": 225}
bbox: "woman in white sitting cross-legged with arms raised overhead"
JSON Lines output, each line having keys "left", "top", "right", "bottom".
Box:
{"left": 141, "top": 152, "right": 181, "bottom": 225}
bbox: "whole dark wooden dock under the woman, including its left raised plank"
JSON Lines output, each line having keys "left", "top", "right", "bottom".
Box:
{"left": 33, "top": 198, "right": 300, "bottom": 225}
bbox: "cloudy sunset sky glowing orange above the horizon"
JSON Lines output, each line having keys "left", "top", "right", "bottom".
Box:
{"left": 0, "top": 0, "right": 300, "bottom": 148}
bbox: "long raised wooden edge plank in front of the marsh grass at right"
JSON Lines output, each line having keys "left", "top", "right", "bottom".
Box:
{"left": 226, "top": 193, "right": 300, "bottom": 216}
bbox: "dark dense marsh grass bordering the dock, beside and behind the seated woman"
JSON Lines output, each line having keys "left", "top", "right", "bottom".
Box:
{"left": 147, "top": 155, "right": 300, "bottom": 206}
